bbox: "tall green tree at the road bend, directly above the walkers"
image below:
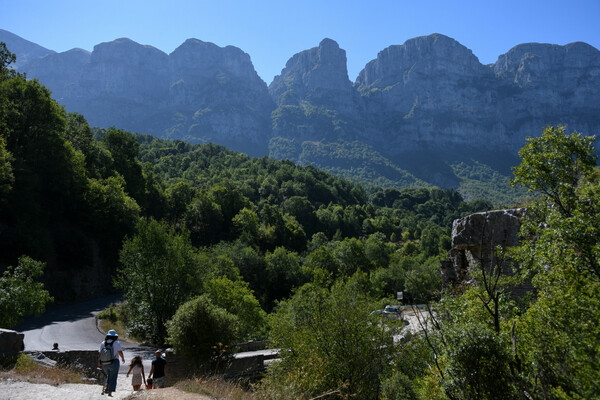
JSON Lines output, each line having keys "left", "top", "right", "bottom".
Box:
{"left": 115, "top": 219, "right": 202, "bottom": 345}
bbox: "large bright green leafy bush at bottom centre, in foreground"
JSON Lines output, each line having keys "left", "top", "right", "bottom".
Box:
{"left": 266, "top": 280, "right": 397, "bottom": 399}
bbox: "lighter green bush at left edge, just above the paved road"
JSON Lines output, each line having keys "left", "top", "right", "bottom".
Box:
{"left": 0, "top": 256, "right": 53, "bottom": 328}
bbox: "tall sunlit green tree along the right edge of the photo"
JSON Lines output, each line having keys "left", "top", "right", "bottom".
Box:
{"left": 511, "top": 127, "right": 600, "bottom": 399}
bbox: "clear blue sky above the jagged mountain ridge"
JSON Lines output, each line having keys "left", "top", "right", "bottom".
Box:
{"left": 0, "top": 0, "right": 600, "bottom": 84}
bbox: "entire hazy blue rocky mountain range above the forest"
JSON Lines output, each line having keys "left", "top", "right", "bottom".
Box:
{"left": 0, "top": 30, "right": 600, "bottom": 202}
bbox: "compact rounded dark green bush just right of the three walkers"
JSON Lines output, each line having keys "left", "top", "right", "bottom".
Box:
{"left": 168, "top": 295, "right": 239, "bottom": 367}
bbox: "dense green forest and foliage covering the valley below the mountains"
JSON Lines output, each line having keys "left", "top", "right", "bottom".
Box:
{"left": 0, "top": 44, "right": 600, "bottom": 400}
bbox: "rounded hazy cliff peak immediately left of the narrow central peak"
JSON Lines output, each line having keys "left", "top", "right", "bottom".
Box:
{"left": 166, "top": 39, "right": 275, "bottom": 155}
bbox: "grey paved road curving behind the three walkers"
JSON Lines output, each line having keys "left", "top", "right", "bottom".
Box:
{"left": 13, "top": 295, "right": 154, "bottom": 375}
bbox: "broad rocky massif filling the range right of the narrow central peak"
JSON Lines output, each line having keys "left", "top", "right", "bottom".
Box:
{"left": 355, "top": 34, "right": 600, "bottom": 153}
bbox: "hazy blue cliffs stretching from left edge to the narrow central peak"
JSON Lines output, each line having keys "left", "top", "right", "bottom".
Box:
{"left": 0, "top": 32, "right": 275, "bottom": 155}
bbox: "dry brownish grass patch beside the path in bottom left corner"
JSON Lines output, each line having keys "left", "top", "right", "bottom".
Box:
{"left": 0, "top": 354, "right": 90, "bottom": 386}
